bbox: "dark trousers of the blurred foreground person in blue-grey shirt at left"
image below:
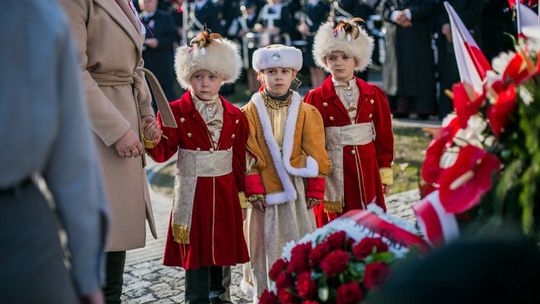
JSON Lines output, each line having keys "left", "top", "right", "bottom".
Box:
{"left": 0, "top": 183, "right": 77, "bottom": 304}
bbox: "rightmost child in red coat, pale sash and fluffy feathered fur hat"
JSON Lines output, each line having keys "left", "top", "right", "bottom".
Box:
{"left": 305, "top": 18, "right": 394, "bottom": 227}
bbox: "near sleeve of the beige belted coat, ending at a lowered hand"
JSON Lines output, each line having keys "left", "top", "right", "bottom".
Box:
{"left": 60, "top": 0, "right": 131, "bottom": 146}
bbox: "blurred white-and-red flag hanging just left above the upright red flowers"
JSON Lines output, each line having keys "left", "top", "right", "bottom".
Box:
{"left": 444, "top": 1, "right": 491, "bottom": 93}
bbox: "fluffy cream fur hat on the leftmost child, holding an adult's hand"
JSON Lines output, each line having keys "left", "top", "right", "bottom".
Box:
{"left": 174, "top": 31, "right": 242, "bottom": 89}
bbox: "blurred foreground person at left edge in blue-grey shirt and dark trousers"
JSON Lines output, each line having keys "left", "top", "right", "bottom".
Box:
{"left": 0, "top": 0, "right": 108, "bottom": 304}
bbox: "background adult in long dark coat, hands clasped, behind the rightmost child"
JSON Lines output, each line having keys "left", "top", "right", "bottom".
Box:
{"left": 378, "top": 0, "right": 437, "bottom": 119}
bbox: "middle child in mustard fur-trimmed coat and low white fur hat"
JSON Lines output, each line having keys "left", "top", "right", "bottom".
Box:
{"left": 241, "top": 45, "right": 330, "bottom": 303}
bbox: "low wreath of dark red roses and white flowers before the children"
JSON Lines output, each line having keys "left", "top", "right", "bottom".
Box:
{"left": 260, "top": 206, "right": 425, "bottom": 304}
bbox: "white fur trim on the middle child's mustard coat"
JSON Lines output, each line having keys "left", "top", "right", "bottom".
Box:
{"left": 251, "top": 92, "right": 319, "bottom": 205}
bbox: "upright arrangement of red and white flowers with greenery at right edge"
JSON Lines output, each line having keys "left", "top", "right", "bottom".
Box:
{"left": 422, "top": 35, "right": 540, "bottom": 234}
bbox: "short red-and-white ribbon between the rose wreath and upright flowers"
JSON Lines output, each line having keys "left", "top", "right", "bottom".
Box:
{"left": 413, "top": 190, "right": 459, "bottom": 246}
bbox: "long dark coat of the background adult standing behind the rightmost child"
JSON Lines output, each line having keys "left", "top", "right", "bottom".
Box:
{"left": 378, "top": 0, "right": 435, "bottom": 97}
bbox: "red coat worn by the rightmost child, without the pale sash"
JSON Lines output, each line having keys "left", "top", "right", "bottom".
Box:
{"left": 304, "top": 76, "right": 394, "bottom": 227}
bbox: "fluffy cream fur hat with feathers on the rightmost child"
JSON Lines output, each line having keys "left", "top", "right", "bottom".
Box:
{"left": 313, "top": 18, "right": 373, "bottom": 72}
